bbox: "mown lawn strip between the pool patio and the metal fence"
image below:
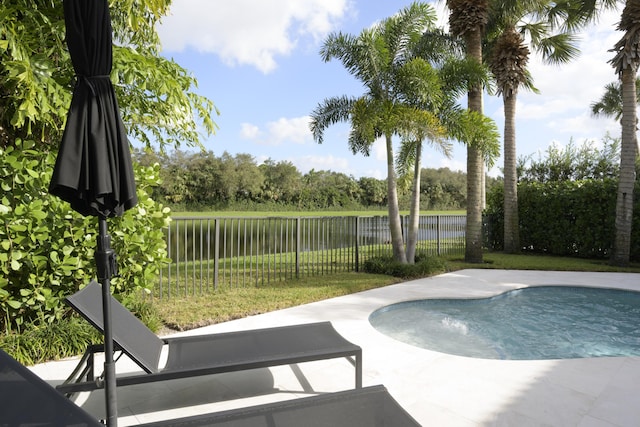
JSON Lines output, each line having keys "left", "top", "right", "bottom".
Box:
{"left": 152, "top": 253, "right": 640, "bottom": 333}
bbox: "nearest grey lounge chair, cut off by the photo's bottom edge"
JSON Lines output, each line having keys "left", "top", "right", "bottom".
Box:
{"left": 0, "top": 350, "right": 420, "bottom": 427}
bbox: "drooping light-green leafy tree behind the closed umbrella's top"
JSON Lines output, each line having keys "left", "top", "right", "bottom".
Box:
{"left": 0, "top": 0, "right": 217, "bottom": 148}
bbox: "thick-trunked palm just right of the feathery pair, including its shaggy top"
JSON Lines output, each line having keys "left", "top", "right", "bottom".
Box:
{"left": 447, "top": 0, "right": 489, "bottom": 263}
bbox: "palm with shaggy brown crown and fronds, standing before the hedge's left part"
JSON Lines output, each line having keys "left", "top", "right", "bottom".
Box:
{"left": 488, "top": 0, "right": 578, "bottom": 253}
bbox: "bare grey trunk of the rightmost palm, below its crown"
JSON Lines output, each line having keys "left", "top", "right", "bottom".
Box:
{"left": 611, "top": 65, "right": 638, "bottom": 266}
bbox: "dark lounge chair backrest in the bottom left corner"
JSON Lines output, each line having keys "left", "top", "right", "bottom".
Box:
{"left": 0, "top": 350, "right": 104, "bottom": 427}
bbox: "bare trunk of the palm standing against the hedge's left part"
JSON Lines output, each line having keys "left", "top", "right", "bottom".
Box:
{"left": 503, "top": 93, "right": 520, "bottom": 254}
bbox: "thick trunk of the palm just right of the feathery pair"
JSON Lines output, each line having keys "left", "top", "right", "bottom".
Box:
{"left": 464, "top": 28, "right": 484, "bottom": 263}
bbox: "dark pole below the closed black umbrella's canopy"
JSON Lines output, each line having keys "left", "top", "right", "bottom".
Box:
{"left": 96, "top": 216, "right": 118, "bottom": 427}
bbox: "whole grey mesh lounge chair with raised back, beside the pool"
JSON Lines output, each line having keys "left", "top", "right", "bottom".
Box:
{"left": 57, "top": 281, "right": 362, "bottom": 394}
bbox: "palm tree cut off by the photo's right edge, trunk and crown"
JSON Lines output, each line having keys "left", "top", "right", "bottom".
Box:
{"left": 609, "top": 1, "right": 640, "bottom": 266}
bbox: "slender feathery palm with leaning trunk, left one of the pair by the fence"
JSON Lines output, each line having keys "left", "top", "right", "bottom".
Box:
{"left": 310, "top": 3, "right": 436, "bottom": 263}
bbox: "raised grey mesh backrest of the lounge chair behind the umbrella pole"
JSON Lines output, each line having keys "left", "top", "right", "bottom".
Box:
{"left": 66, "top": 280, "right": 164, "bottom": 373}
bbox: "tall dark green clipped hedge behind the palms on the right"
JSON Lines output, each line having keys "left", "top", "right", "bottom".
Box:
{"left": 485, "top": 179, "right": 640, "bottom": 261}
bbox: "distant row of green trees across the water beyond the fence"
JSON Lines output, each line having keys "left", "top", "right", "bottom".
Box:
{"left": 133, "top": 149, "right": 480, "bottom": 211}
